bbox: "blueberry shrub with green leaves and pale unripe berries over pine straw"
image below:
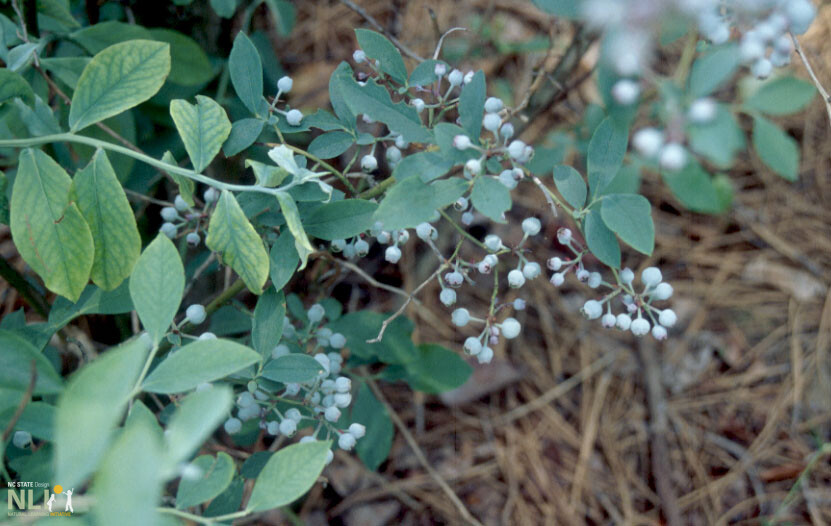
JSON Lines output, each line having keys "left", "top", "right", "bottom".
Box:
{"left": 0, "top": 0, "right": 817, "bottom": 524}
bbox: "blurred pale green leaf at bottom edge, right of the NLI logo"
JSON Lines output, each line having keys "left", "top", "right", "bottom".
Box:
{"left": 92, "top": 420, "right": 162, "bottom": 526}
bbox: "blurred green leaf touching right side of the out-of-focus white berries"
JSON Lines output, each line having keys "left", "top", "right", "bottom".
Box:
{"left": 687, "top": 104, "right": 746, "bottom": 168}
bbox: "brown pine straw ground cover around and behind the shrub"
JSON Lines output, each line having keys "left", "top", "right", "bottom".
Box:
{"left": 0, "top": 0, "right": 831, "bottom": 526}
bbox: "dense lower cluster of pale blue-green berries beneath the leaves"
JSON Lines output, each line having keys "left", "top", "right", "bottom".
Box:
{"left": 224, "top": 304, "right": 366, "bottom": 464}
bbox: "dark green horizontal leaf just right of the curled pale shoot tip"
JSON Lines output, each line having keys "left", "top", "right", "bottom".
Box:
{"left": 303, "top": 199, "right": 378, "bottom": 241}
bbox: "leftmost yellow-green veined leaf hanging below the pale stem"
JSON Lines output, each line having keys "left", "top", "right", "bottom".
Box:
{"left": 10, "top": 149, "right": 94, "bottom": 301}
